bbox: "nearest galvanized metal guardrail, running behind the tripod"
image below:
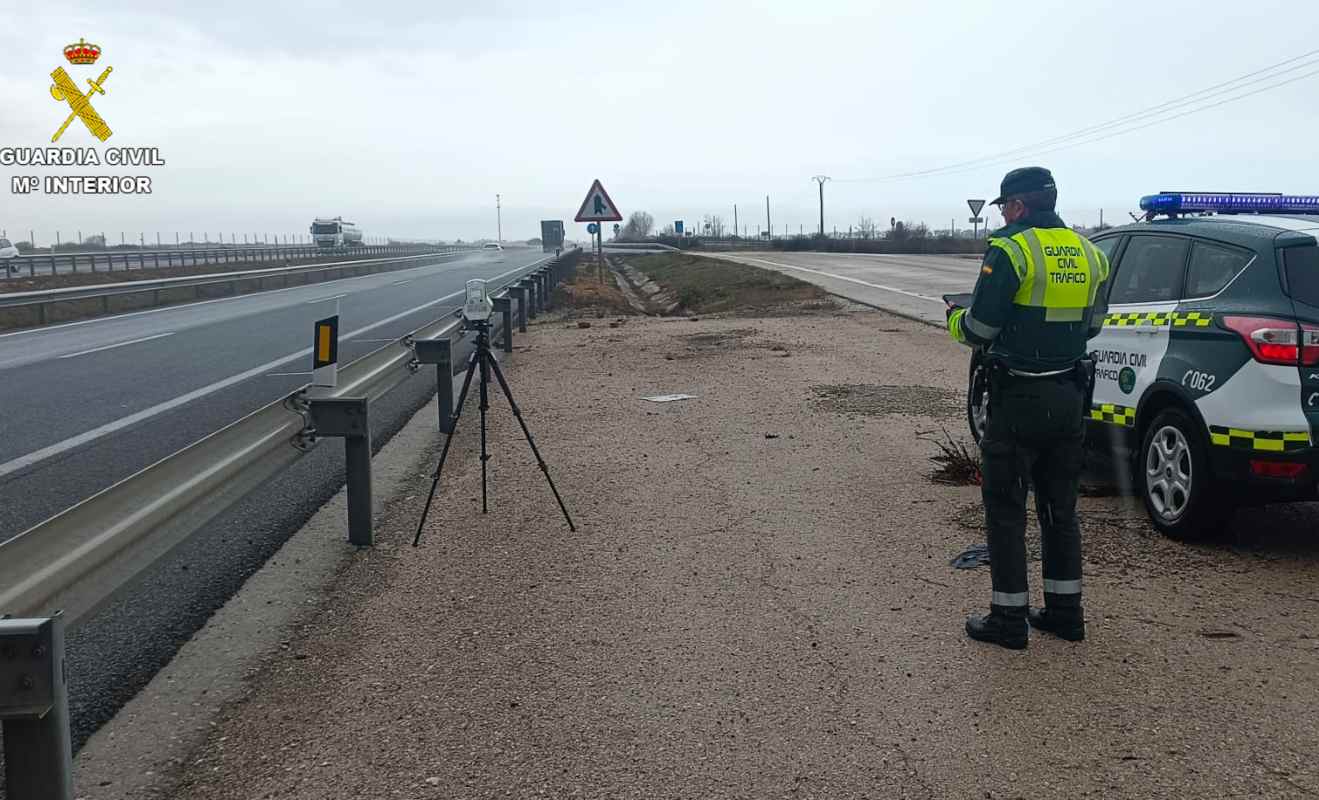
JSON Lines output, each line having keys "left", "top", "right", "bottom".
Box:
{"left": 0, "top": 250, "right": 580, "bottom": 626}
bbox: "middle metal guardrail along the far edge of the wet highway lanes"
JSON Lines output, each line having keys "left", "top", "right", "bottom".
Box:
{"left": 0, "top": 248, "right": 482, "bottom": 326}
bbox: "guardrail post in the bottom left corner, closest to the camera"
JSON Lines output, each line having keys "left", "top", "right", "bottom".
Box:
{"left": 0, "top": 615, "right": 74, "bottom": 800}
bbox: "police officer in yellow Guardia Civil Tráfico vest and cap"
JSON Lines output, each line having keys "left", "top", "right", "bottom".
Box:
{"left": 948, "top": 166, "right": 1108, "bottom": 650}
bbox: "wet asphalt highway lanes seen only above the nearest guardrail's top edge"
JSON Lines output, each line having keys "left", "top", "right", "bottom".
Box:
{"left": 0, "top": 250, "right": 542, "bottom": 540}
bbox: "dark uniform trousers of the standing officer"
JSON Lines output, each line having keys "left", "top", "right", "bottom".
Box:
{"left": 980, "top": 368, "right": 1084, "bottom": 617}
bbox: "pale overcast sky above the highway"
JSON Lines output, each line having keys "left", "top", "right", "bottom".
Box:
{"left": 0, "top": 0, "right": 1319, "bottom": 244}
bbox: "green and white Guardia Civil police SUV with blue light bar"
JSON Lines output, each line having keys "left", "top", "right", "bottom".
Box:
{"left": 967, "top": 192, "right": 1319, "bottom": 539}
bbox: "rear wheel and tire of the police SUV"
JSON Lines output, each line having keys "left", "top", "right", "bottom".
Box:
{"left": 1133, "top": 407, "right": 1236, "bottom": 542}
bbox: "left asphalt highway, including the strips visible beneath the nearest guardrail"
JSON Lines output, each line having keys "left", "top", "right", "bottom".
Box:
{"left": 0, "top": 249, "right": 543, "bottom": 745}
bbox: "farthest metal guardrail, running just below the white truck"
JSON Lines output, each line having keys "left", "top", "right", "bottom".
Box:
{"left": 0, "top": 244, "right": 464, "bottom": 281}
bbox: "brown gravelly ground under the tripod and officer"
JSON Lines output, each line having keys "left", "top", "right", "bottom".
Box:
{"left": 159, "top": 301, "right": 1319, "bottom": 800}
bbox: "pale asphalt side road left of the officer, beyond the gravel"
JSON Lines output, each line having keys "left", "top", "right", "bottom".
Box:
{"left": 702, "top": 252, "right": 980, "bottom": 326}
